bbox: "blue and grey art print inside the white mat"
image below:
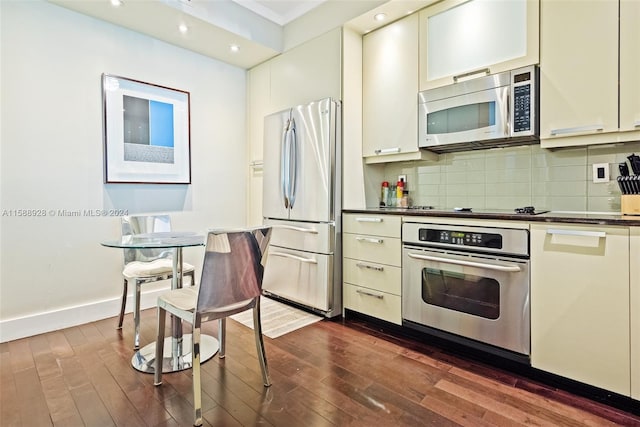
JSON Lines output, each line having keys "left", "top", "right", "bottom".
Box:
{"left": 122, "top": 95, "right": 174, "bottom": 163}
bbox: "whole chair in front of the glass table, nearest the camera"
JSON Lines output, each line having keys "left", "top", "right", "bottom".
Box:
{"left": 154, "top": 227, "right": 271, "bottom": 425}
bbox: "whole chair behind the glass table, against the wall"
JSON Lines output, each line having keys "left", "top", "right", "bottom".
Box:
{"left": 118, "top": 215, "right": 195, "bottom": 350}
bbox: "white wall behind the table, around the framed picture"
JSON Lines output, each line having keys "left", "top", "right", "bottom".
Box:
{"left": 0, "top": 0, "right": 246, "bottom": 341}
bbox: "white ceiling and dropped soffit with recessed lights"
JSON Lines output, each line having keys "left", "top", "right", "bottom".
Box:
{"left": 48, "top": 0, "right": 437, "bottom": 69}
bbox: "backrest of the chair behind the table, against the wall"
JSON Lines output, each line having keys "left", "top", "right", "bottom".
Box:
{"left": 122, "top": 215, "right": 171, "bottom": 264}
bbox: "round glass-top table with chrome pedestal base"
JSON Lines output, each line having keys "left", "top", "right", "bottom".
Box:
{"left": 101, "top": 232, "right": 219, "bottom": 373}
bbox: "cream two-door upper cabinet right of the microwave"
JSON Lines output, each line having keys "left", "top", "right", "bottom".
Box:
{"left": 540, "top": 0, "right": 640, "bottom": 148}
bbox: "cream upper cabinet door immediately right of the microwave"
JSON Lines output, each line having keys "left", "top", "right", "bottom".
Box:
{"left": 540, "top": 0, "right": 618, "bottom": 146}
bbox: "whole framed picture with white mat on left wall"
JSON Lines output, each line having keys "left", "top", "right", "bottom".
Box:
{"left": 102, "top": 74, "right": 191, "bottom": 184}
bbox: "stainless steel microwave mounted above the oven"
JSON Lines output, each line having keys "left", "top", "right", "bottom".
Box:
{"left": 418, "top": 66, "right": 540, "bottom": 152}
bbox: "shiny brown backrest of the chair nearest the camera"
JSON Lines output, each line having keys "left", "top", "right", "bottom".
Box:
{"left": 196, "top": 227, "right": 271, "bottom": 313}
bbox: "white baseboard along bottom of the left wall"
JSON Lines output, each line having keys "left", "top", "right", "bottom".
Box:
{"left": 0, "top": 287, "right": 170, "bottom": 343}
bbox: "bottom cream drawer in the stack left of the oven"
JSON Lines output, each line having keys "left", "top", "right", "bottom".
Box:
{"left": 342, "top": 283, "right": 402, "bottom": 325}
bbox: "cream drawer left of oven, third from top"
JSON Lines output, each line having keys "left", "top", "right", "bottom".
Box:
{"left": 342, "top": 258, "right": 402, "bottom": 295}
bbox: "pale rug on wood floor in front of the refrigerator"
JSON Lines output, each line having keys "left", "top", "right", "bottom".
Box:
{"left": 231, "top": 297, "right": 323, "bottom": 338}
